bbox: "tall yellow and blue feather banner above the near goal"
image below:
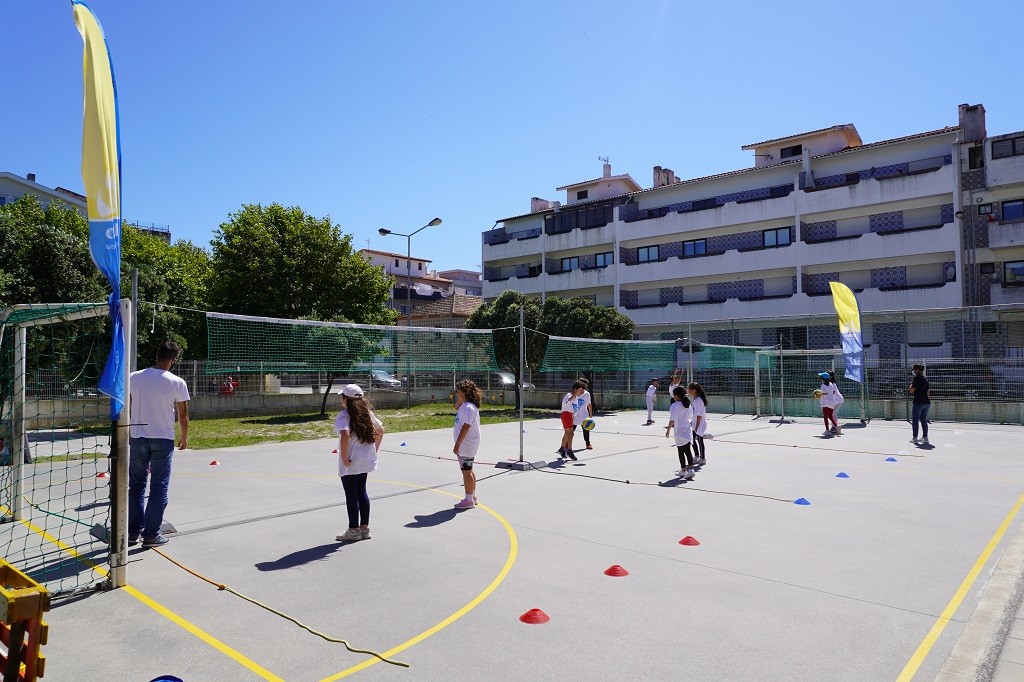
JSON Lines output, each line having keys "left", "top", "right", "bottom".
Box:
{"left": 72, "top": 0, "right": 125, "bottom": 419}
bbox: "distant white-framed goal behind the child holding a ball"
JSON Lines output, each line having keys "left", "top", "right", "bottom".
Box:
{"left": 755, "top": 348, "right": 870, "bottom": 422}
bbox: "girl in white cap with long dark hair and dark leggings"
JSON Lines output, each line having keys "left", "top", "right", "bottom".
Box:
{"left": 334, "top": 384, "right": 384, "bottom": 543}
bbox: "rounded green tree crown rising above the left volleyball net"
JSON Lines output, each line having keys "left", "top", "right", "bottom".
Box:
{"left": 209, "top": 204, "right": 395, "bottom": 325}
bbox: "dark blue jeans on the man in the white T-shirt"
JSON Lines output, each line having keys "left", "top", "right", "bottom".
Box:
{"left": 128, "top": 438, "right": 174, "bottom": 538}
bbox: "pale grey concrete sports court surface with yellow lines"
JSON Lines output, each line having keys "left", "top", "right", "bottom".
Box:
{"left": 28, "top": 405, "right": 1024, "bottom": 682}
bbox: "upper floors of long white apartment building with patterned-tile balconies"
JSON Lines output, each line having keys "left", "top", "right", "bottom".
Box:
{"left": 482, "top": 104, "right": 1024, "bottom": 356}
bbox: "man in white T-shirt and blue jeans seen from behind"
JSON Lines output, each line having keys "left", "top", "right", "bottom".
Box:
{"left": 128, "top": 341, "right": 188, "bottom": 547}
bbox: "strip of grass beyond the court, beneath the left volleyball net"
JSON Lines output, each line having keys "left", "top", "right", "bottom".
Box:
{"left": 188, "top": 403, "right": 558, "bottom": 450}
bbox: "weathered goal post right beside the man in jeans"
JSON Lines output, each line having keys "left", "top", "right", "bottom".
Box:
{"left": 110, "top": 299, "right": 135, "bottom": 588}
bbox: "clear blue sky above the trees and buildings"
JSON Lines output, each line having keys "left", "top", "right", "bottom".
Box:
{"left": 0, "top": 0, "right": 1024, "bottom": 269}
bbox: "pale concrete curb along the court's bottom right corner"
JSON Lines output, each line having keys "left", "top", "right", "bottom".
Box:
{"left": 935, "top": 524, "right": 1024, "bottom": 682}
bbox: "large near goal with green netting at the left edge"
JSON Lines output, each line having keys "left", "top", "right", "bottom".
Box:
{"left": 0, "top": 303, "right": 111, "bottom": 595}
